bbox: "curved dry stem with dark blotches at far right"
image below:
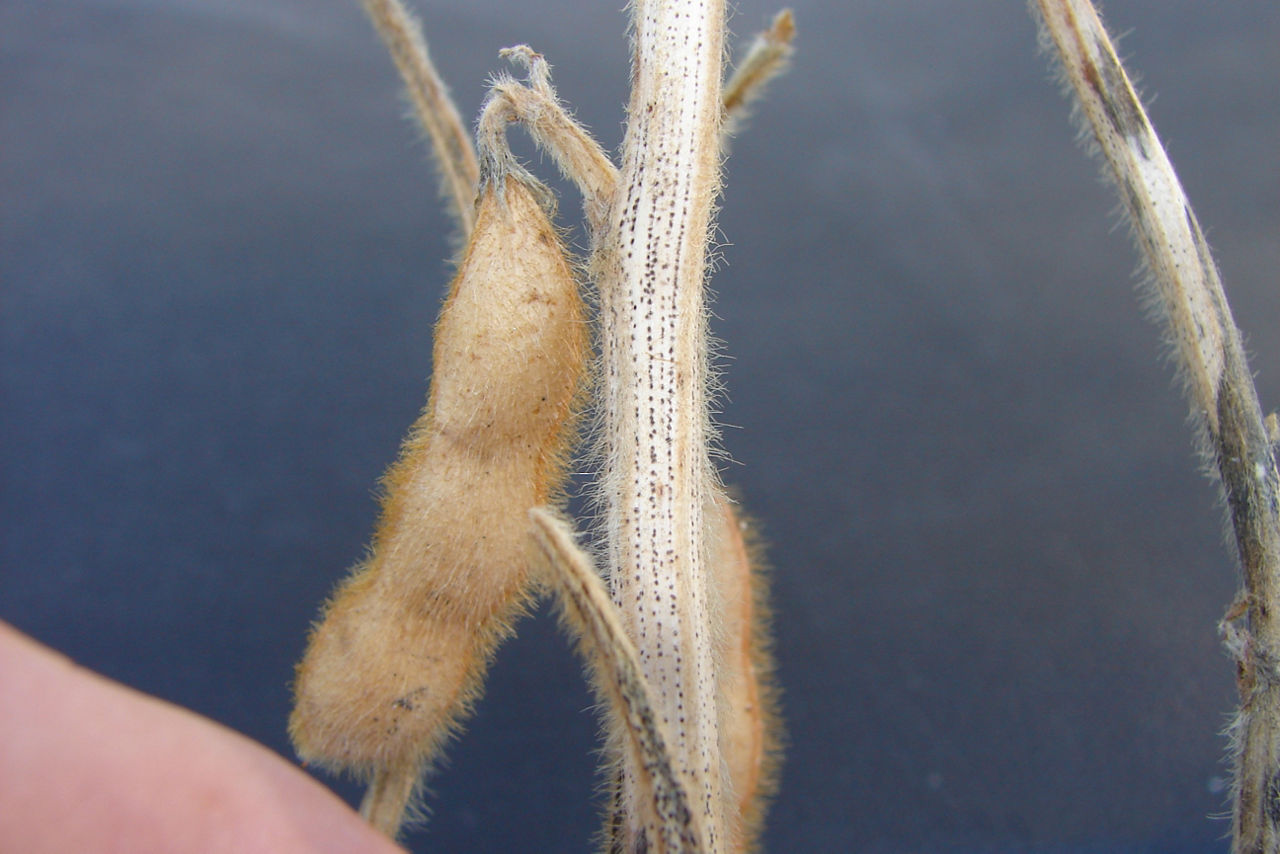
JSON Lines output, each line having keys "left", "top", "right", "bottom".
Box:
{"left": 1036, "top": 0, "right": 1280, "bottom": 854}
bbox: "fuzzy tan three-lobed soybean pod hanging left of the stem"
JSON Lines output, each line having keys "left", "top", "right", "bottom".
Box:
{"left": 289, "top": 169, "right": 589, "bottom": 776}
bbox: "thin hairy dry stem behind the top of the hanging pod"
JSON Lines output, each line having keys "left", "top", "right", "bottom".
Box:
{"left": 364, "top": 0, "right": 480, "bottom": 231}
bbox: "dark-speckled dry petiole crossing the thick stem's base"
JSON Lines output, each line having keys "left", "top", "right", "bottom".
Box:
{"left": 529, "top": 507, "right": 701, "bottom": 854}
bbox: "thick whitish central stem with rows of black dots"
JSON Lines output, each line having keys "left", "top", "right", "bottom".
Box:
{"left": 595, "top": 0, "right": 726, "bottom": 851}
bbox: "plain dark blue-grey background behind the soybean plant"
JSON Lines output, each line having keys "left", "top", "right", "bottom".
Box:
{"left": 0, "top": 0, "right": 1280, "bottom": 851}
